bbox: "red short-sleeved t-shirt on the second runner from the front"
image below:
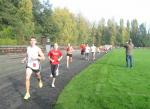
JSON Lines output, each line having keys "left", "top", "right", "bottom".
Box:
{"left": 48, "top": 49, "right": 62, "bottom": 65}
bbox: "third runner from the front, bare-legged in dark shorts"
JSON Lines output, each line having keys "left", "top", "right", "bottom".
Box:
{"left": 66, "top": 43, "right": 73, "bottom": 68}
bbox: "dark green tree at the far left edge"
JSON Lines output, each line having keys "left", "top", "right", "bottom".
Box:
{"left": 0, "top": 0, "right": 20, "bottom": 39}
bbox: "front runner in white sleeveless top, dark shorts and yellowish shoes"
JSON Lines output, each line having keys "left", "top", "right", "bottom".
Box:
{"left": 22, "top": 37, "right": 45, "bottom": 100}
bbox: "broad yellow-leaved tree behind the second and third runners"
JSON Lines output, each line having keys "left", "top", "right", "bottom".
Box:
{"left": 52, "top": 8, "right": 81, "bottom": 44}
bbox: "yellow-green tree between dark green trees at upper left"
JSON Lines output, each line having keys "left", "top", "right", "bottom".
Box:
{"left": 18, "top": 0, "right": 34, "bottom": 43}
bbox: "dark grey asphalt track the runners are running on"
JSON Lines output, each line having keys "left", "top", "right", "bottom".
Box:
{"left": 0, "top": 50, "right": 104, "bottom": 109}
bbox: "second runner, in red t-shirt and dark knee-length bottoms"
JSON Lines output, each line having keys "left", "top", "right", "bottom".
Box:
{"left": 48, "top": 43, "right": 63, "bottom": 87}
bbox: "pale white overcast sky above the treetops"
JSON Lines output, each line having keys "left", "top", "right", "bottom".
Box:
{"left": 41, "top": 0, "right": 150, "bottom": 27}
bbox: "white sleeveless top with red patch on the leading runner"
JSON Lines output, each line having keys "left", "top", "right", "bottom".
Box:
{"left": 27, "top": 46, "right": 40, "bottom": 70}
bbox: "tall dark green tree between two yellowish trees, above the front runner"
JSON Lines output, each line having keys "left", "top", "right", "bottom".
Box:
{"left": 32, "top": 0, "right": 55, "bottom": 39}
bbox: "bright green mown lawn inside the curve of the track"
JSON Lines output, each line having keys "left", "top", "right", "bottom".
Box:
{"left": 55, "top": 49, "right": 150, "bottom": 109}
